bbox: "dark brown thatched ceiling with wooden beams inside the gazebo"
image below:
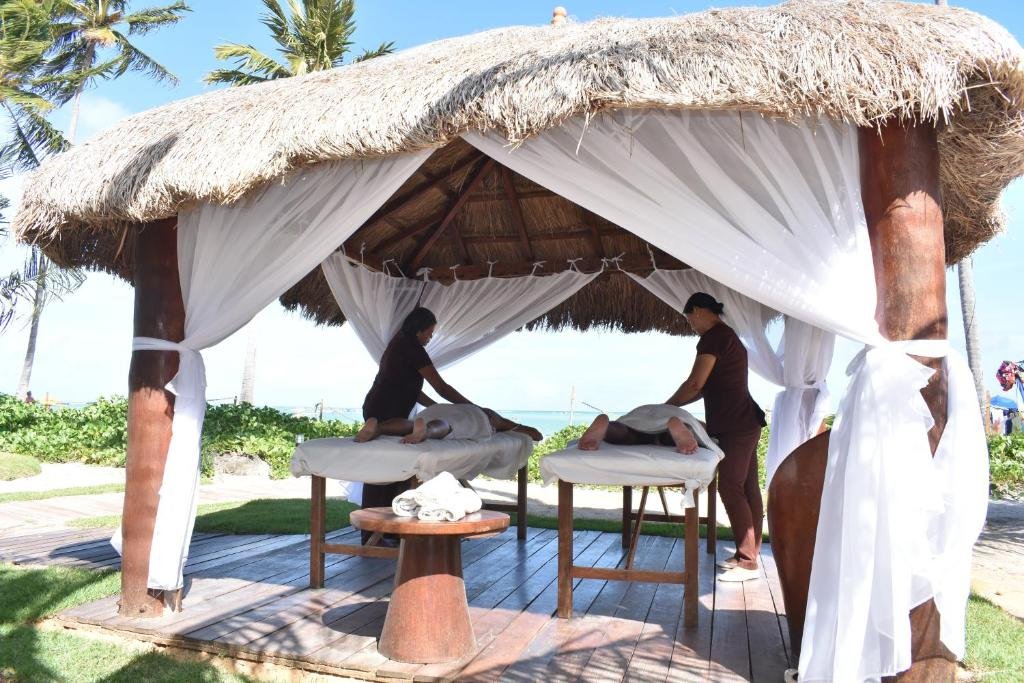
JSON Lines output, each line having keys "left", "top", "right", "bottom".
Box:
{"left": 281, "top": 139, "right": 692, "bottom": 334}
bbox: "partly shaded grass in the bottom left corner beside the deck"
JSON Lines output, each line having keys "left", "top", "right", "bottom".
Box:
{"left": 0, "top": 564, "right": 264, "bottom": 683}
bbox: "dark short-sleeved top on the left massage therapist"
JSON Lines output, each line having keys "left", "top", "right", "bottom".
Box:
{"left": 362, "top": 332, "right": 433, "bottom": 420}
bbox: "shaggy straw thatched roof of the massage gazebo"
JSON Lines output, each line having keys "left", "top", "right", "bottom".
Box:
{"left": 15, "top": 0, "right": 1024, "bottom": 327}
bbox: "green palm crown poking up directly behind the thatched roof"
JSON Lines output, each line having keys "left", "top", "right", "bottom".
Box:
{"left": 204, "top": 0, "right": 394, "bottom": 85}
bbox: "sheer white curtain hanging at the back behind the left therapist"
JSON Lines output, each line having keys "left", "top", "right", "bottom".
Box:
{"left": 322, "top": 253, "right": 600, "bottom": 369}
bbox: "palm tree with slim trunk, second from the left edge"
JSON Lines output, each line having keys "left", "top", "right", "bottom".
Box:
{"left": 45, "top": 0, "right": 190, "bottom": 142}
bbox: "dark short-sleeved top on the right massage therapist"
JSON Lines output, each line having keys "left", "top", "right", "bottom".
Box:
{"left": 697, "top": 323, "right": 765, "bottom": 435}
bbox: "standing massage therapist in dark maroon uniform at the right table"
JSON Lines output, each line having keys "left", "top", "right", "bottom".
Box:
{"left": 666, "top": 292, "right": 765, "bottom": 582}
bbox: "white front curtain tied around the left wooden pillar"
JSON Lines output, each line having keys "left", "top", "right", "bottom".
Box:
{"left": 115, "top": 151, "right": 430, "bottom": 590}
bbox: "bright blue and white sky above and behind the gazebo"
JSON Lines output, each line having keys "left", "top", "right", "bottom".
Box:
{"left": 0, "top": 0, "right": 1024, "bottom": 411}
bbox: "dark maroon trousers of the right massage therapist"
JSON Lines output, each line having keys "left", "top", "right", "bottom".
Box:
{"left": 716, "top": 429, "right": 765, "bottom": 569}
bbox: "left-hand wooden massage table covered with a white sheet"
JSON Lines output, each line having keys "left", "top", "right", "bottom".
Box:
{"left": 292, "top": 432, "right": 534, "bottom": 588}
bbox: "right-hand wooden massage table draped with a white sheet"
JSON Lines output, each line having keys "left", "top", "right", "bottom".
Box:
{"left": 541, "top": 443, "right": 722, "bottom": 627}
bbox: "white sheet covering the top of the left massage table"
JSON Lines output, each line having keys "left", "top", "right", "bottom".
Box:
{"left": 292, "top": 432, "right": 534, "bottom": 483}
